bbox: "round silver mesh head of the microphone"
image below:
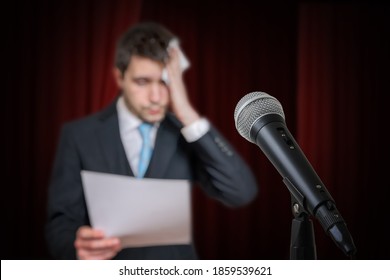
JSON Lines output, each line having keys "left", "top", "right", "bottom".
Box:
{"left": 234, "top": 91, "right": 284, "bottom": 143}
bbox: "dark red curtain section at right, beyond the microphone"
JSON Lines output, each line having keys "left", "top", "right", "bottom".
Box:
{"left": 297, "top": 3, "right": 390, "bottom": 259}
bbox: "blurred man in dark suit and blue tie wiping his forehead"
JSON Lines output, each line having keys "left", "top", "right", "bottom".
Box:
{"left": 46, "top": 22, "right": 257, "bottom": 259}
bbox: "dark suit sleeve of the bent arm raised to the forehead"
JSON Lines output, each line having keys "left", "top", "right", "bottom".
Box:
{"left": 190, "top": 126, "right": 258, "bottom": 207}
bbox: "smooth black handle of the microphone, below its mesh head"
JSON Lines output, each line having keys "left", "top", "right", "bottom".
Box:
{"left": 251, "top": 115, "right": 333, "bottom": 217}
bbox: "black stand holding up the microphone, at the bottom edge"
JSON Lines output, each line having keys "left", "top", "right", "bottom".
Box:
{"left": 290, "top": 196, "right": 317, "bottom": 260}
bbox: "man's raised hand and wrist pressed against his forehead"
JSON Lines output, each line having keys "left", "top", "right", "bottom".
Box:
{"left": 166, "top": 47, "right": 200, "bottom": 126}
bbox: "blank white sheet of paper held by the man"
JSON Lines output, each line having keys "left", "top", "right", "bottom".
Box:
{"left": 81, "top": 170, "right": 191, "bottom": 247}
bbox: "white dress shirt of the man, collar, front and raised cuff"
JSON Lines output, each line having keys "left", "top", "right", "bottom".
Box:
{"left": 116, "top": 96, "right": 210, "bottom": 175}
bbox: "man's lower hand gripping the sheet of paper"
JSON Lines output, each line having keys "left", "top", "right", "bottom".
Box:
{"left": 74, "top": 226, "right": 122, "bottom": 260}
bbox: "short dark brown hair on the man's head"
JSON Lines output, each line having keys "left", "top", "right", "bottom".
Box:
{"left": 115, "top": 22, "right": 175, "bottom": 74}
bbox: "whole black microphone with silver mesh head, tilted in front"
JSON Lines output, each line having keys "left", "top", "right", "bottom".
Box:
{"left": 234, "top": 92, "right": 356, "bottom": 257}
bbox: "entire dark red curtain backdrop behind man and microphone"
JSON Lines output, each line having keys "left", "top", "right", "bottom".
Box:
{"left": 0, "top": 0, "right": 390, "bottom": 259}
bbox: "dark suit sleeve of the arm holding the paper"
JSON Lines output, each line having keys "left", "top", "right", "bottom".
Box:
{"left": 45, "top": 125, "right": 88, "bottom": 259}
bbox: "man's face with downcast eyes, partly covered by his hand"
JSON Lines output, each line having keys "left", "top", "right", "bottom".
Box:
{"left": 115, "top": 56, "right": 169, "bottom": 123}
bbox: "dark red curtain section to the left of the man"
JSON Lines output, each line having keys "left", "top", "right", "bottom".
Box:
{"left": 2, "top": 0, "right": 141, "bottom": 259}
